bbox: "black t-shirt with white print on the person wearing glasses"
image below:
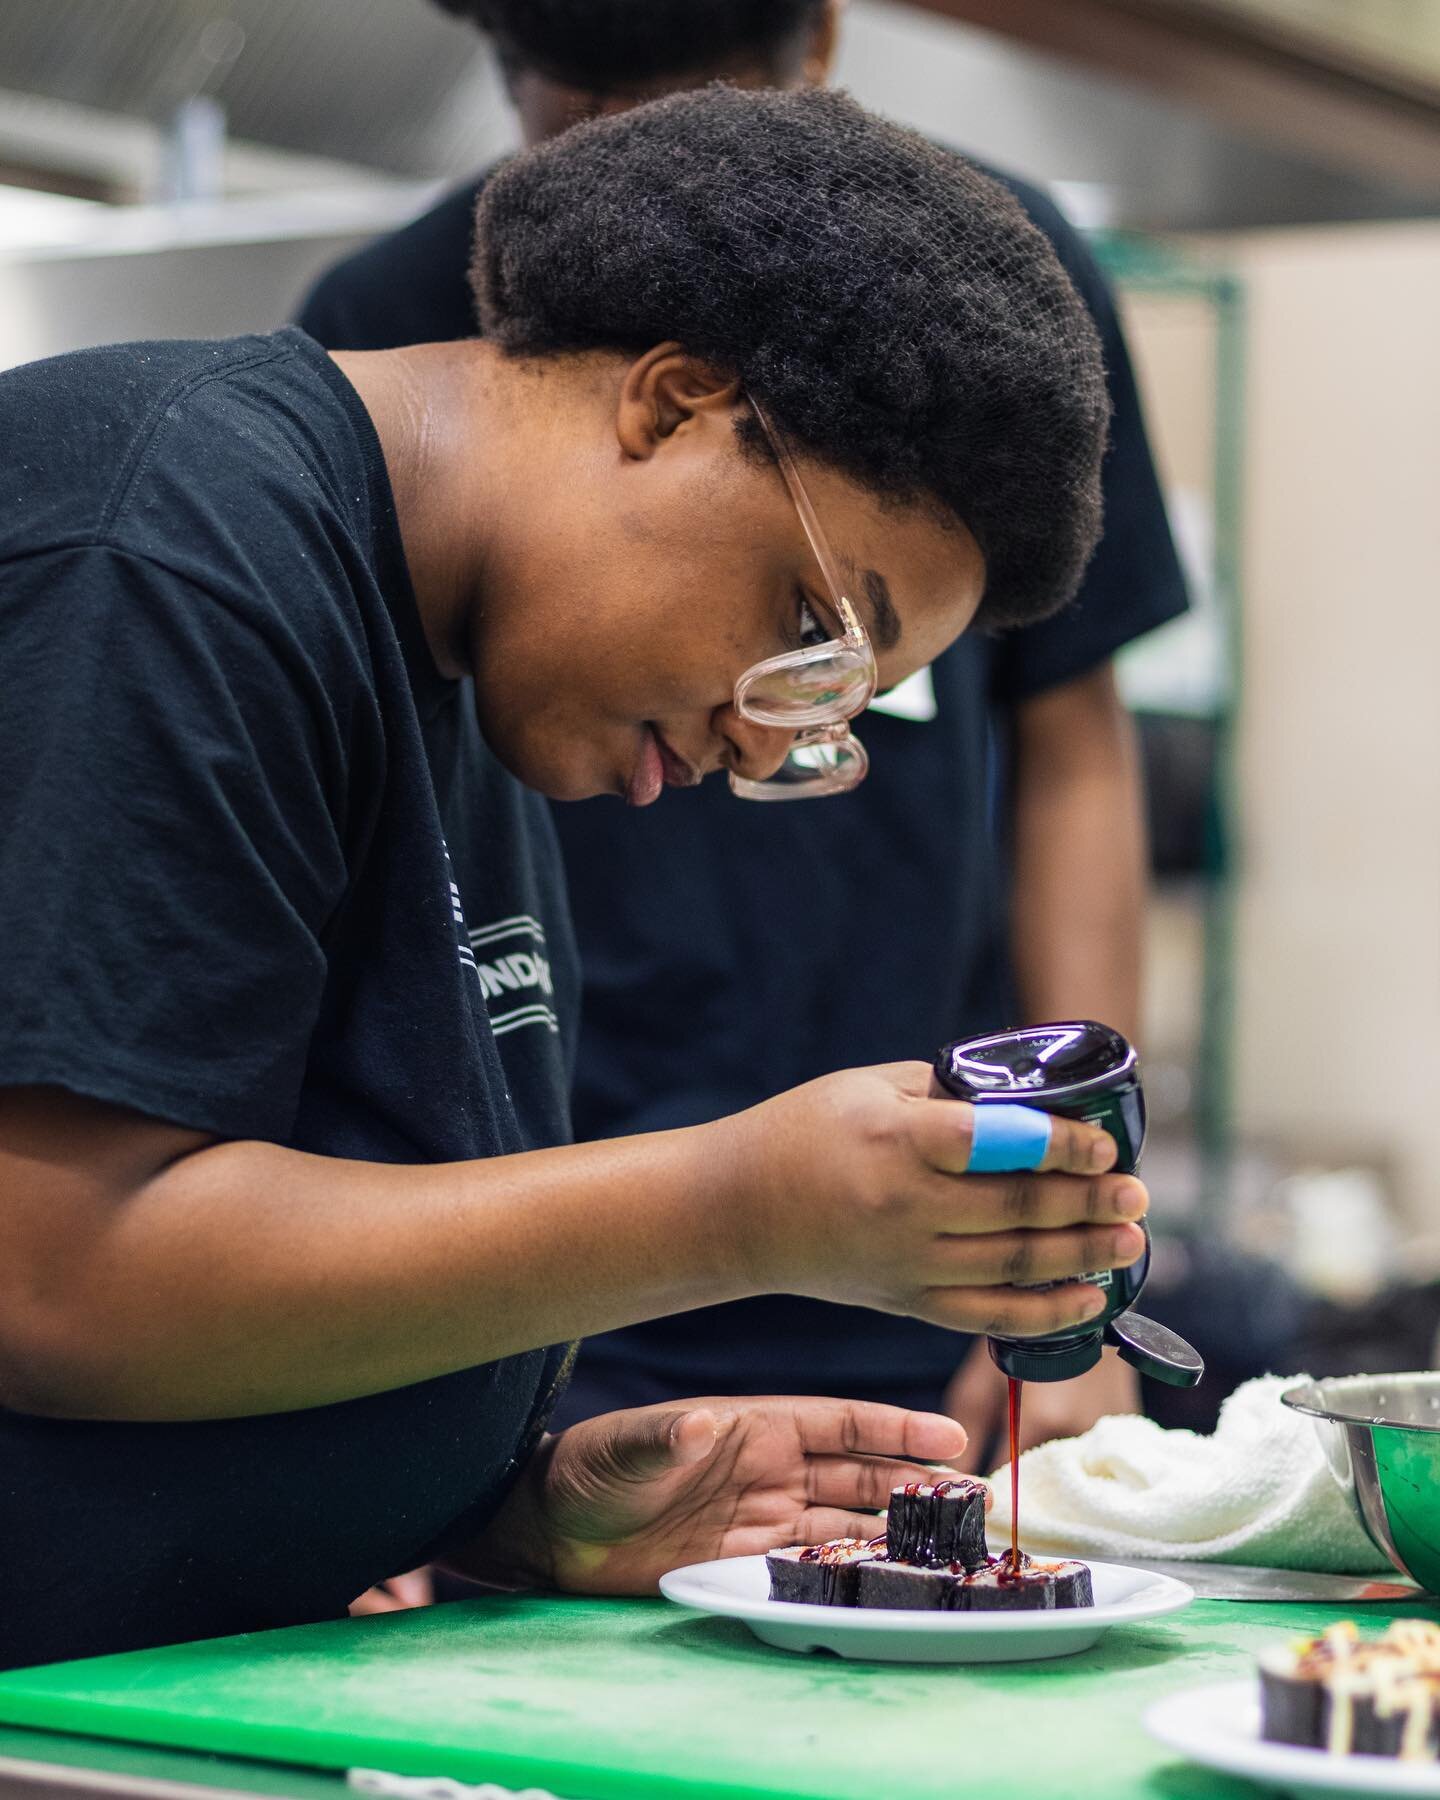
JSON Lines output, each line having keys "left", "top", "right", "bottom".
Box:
{"left": 0, "top": 329, "right": 578, "bottom": 1663}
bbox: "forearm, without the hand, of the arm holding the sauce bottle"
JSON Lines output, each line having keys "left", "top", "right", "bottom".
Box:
{"left": 5, "top": 1101, "right": 749, "bottom": 1418}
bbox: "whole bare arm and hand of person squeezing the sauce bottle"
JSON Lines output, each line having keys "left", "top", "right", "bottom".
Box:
{"left": 0, "top": 1062, "right": 1147, "bottom": 1418}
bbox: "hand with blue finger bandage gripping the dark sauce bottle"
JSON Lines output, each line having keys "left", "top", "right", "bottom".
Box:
{"left": 711, "top": 1062, "right": 1148, "bottom": 1337}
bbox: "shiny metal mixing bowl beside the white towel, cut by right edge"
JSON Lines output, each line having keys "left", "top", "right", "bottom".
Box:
{"left": 1282, "top": 1373, "right": 1440, "bottom": 1593}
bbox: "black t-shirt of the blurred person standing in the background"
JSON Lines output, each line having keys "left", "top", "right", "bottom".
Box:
{"left": 301, "top": 158, "right": 1186, "bottom": 1399}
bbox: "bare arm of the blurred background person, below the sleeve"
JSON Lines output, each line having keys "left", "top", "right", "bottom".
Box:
{"left": 1012, "top": 664, "right": 1145, "bottom": 1039}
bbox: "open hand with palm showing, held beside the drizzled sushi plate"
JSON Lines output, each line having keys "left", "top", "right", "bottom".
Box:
{"left": 452, "top": 1397, "right": 965, "bottom": 1595}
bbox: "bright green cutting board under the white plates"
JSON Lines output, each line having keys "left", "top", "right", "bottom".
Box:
{"left": 0, "top": 1597, "right": 1420, "bottom": 1800}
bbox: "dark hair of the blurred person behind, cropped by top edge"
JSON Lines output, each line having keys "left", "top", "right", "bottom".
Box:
{"left": 437, "top": 0, "right": 824, "bottom": 92}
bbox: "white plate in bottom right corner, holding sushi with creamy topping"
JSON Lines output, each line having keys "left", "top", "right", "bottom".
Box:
{"left": 1145, "top": 1679, "right": 1440, "bottom": 1800}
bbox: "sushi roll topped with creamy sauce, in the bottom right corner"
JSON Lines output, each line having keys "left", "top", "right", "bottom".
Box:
{"left": 1260, "top": 1618, "right": 1440, "bottom": 1762}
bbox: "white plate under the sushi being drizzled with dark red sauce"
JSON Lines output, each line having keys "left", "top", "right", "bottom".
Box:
{"left": 661, "top": 1557, "right": 1193, "bottom": 1663}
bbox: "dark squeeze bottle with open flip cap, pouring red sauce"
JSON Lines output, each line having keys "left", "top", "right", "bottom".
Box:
{"left": 934, "top": 1019, "right": 1204, "bottom": 1388}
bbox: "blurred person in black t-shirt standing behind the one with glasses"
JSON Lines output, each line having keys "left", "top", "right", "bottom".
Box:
{"left": 299, "top": 0, "right": 1186, "bottom": 1467}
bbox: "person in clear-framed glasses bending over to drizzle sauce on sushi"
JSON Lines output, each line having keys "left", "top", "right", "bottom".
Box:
{"left": 0, "top": 88, "right": 1147, "bottom": 1663}
